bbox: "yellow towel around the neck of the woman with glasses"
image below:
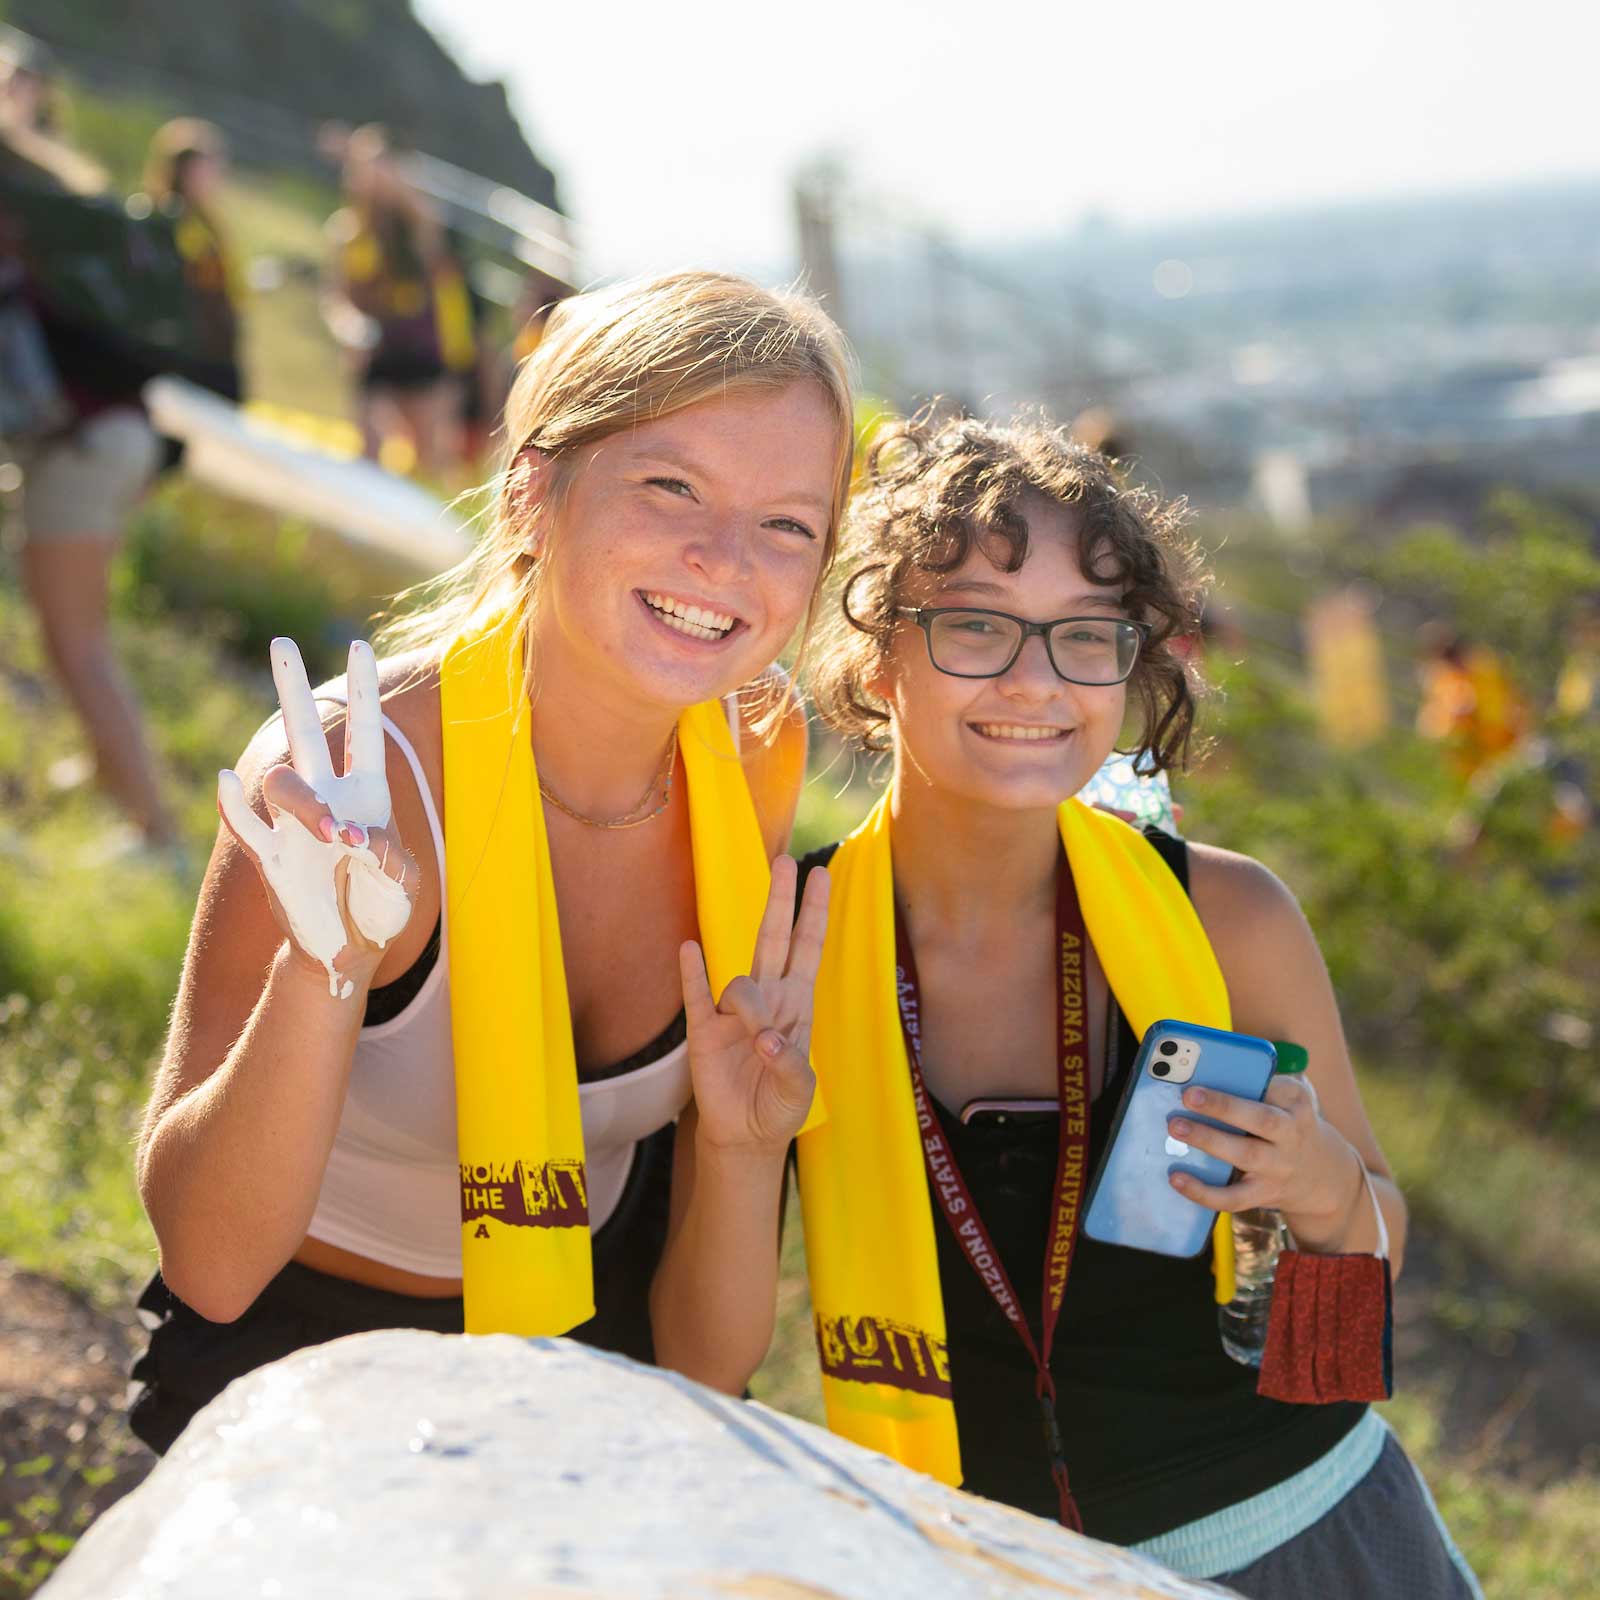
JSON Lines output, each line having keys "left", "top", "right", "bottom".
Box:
{"left": 798, "top": 795, "right": 1234, "bottom": 1485}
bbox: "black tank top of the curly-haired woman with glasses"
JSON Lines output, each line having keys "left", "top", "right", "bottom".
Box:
{"left": 802, "top": 829, "right": 1366, "bottom": 1544}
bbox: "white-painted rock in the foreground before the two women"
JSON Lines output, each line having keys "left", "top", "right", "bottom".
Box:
{"left": 43, "top": 1331, "right": 1222, "bottom": 1600}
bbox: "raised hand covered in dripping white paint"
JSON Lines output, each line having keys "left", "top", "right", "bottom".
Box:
{"left": 216, "top": 638, "right": 419, "bottom": 998}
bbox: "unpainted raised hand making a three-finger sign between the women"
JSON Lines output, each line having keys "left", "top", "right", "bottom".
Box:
{"left": 678, "top": 856, "right": 827, "bottom": 1149}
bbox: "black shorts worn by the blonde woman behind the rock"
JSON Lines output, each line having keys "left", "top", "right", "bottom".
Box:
{"left": 128, "top": 1123, "right": 674, "bottom": 1454}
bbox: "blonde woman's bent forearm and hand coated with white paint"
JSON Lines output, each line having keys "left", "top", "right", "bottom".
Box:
{"left": 138, "top": 640, "right": 421, "bottom": 1322}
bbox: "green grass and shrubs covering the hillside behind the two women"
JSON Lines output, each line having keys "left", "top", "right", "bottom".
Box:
{"left": 0, "top": 78, "right": 1600, "bottom": 1597}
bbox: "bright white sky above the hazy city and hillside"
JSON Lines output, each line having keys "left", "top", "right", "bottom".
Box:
{"left": 414, "top": 0, "right": 1600, "bottom": 275}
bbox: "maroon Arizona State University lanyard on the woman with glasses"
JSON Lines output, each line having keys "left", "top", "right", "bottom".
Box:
{"left": 894, "top": 866, "right": 1090, "bottom": 1533}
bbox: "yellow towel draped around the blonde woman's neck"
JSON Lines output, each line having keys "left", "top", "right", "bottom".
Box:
{"left": 438, "top": 613, "right": 771, "bottom": 1336}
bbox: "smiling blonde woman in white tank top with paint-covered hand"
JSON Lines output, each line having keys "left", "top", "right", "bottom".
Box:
{"left": 133, "top": 274, "right": 851, "bottom": 1450}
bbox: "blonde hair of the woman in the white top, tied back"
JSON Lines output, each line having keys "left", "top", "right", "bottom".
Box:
{"left": 378, "top": 272, "right": 853, "bottom": 720}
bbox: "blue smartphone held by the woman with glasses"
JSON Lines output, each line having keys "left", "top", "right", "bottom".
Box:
{"left": 1083, "top": 1021, "right": 1277, "bottom": 1256}
